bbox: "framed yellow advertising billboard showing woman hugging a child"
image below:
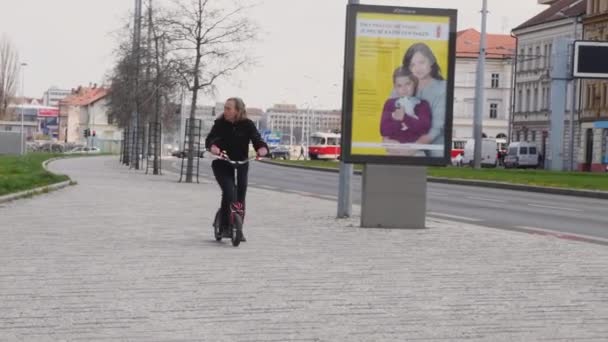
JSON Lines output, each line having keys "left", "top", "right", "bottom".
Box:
{"left": 342, "top": 5, "right": 457, "bottom": 165}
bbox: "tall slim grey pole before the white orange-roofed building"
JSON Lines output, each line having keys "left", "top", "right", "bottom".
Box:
{"left": 473, "top": 0, "right": 488, "bottom": 169}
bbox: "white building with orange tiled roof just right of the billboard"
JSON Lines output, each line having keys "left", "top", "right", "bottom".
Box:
{"left": 452, "top": 29, "right": 515, "bottom": 139}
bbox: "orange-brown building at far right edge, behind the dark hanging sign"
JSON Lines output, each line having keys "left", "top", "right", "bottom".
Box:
{"left": 578, "top": 0, "right": 608, "bottom": 172}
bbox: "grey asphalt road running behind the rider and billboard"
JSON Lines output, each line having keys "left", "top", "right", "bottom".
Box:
{"left": 163, "top": 159, "right": 608, "bottom": 243}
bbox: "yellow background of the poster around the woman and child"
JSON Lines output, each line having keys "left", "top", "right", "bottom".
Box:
{"left": 351, "top": 13, "right": 450, "bottom": 156}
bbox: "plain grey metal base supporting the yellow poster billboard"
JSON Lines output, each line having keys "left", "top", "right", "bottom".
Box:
{"left": 361, "top": 164, "right": 427, "bottom": 229}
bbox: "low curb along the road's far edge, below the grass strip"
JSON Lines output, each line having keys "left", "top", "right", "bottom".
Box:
{"left": 262, "top": 160, "right": 608, "bottom": 199}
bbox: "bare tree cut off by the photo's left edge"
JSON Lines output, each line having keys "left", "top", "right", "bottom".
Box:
{"left": 0, "top": 35, "right": 19, "bottom": 117}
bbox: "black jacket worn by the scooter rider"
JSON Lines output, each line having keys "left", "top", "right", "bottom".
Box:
{"left": 205, "top": 117, "right": 268, "bottom": 161}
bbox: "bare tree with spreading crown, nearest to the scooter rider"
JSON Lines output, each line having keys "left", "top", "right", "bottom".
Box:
{"left": 162, "top": 0, "right": 257, "bottom": 183}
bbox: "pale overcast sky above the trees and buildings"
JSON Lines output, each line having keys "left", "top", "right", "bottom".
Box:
{"left": 0, "top": 0, "right": 545, "bottom": 108}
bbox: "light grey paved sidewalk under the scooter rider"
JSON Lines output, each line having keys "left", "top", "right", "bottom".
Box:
{"left": 0, "top": 157, "right": 608, "bottom": 342}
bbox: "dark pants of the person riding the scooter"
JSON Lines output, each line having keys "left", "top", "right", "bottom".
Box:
{"left": 211, "top": 160, "right": 249, "bottom": 226}
